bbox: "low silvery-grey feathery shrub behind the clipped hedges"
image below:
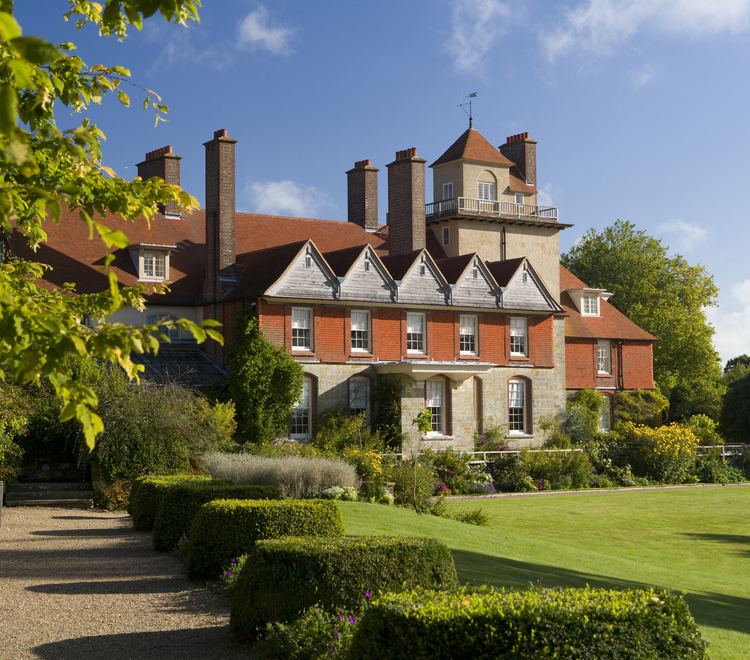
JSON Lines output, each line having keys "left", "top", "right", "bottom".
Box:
{"left": 203, "top": 452, "right": 359, "bottom": 499}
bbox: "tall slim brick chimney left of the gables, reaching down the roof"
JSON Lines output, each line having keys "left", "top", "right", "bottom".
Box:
{"left": 203, "top": 128, "right": 237, "bottom": 302}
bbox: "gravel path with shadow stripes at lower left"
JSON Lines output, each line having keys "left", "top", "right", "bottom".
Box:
{"left": 0, "top": 507, "right": 251, "bottom": 660}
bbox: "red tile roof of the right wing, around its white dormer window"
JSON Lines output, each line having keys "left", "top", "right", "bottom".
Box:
{"left": 560, "top": 266, "right": 656, "bottom": 341}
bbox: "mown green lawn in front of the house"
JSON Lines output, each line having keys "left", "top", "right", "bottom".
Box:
{"left": 341, "top": 486, "right": 750, "bottom": 658}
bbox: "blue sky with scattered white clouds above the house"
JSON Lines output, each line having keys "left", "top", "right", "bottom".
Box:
{"left": 16, "top": 0, "right": 750, "bottom": 360}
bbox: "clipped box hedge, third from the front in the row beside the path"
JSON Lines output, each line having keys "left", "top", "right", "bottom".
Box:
{"left": 187, "top": 499, "right": 344, "bottom": 579}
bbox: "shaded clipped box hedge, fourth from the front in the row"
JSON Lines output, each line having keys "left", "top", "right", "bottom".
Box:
{"left": 154, "top": 481, "right": 281, "bottom": 550}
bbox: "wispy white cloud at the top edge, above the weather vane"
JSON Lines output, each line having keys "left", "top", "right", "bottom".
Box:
{"left": 446, "top": 0, "right": 512, "bottom": 74}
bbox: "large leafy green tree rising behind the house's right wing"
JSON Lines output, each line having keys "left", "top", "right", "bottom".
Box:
{"left": 561, "top": 220, "right": 723, "bottom": 419}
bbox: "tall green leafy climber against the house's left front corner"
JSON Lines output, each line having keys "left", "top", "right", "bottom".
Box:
{"left": 229, "top": 316, "right": 304, "bottom": 444}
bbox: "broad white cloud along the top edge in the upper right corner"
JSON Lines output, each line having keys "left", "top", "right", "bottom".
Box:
{"left": 540, "top": 0, "right": 750, "bottom": 60}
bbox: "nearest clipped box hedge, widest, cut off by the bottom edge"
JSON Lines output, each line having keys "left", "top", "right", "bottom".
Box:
{"left": 350, "top": 587, "right": 708, "bottom": 660}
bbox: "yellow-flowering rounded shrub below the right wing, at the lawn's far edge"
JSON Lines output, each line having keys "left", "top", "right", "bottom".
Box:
{"left": 623, "top": 423, "right": 698, "bottom": 484}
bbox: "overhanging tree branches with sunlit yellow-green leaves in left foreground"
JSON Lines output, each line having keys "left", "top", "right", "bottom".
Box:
{"left": 0, "top": 0, "right": 221, "bottom": 448}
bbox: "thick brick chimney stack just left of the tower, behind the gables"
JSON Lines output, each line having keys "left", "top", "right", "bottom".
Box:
{"left": 387, "top": 147, "right": 426, "bottom": 255}
